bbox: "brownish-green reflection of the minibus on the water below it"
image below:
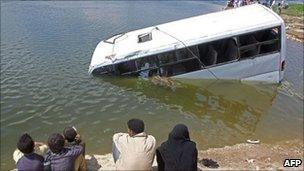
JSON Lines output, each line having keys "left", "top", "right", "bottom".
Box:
{"left": 103, "top": 78, "right": 276, "bottom": 119}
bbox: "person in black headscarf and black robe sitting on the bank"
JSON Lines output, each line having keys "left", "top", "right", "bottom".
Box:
{"left": 156, "top": 124, "right": 197, "bottom": 171}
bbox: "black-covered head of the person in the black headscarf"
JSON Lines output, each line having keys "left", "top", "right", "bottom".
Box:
{"left": 169, "top": 124, "right": 190, "bottom": 140}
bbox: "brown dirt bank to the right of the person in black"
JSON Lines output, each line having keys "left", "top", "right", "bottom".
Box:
{"left": 199, "top": 140, "right": 304, "bottom": 170}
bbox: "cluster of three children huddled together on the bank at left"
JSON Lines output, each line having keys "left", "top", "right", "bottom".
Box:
{"left": 13, "top": 127, "right": 86, "bottom": 171}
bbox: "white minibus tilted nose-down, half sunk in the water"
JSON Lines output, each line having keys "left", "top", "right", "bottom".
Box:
{"left": 89, "top": 4, "right": 286, "bottom": 83}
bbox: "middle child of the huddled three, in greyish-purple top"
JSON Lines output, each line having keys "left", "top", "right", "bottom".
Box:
{"left": 44, "top": 133, "right": 86, "bottom": 171}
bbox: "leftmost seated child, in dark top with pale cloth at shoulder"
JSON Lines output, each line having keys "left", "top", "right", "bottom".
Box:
{"left": 14, "top": 133, "right": 44, "bottom": 171}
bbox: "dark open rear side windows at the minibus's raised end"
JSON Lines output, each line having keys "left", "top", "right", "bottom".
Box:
{"left": 198, "top": 28, "right": 280, "bottom": 66}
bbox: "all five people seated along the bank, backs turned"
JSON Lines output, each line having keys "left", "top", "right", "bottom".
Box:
{"left": 14, "top": 119, "right": 197, "bottom": 171}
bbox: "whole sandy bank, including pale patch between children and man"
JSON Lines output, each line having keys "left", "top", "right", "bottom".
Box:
{"left": 86, "top": 140, "right": 304, "bottom": 170}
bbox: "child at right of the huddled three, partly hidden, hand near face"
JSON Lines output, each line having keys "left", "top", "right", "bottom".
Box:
{"left": 63, "top": 126, "right": 86, "bottom": 170}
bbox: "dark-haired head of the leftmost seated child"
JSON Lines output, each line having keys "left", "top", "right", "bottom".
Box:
{"left": 17, "top": 133, "right": 35, "bottom": 154}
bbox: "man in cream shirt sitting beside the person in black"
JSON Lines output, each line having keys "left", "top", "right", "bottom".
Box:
{"left": 112, "top": 119, "right": 156, "bottom": 170}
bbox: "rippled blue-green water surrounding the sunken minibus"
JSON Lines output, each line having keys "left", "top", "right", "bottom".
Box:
{"left": 0, "top": 1, "right": 303, "bottom": 170}
